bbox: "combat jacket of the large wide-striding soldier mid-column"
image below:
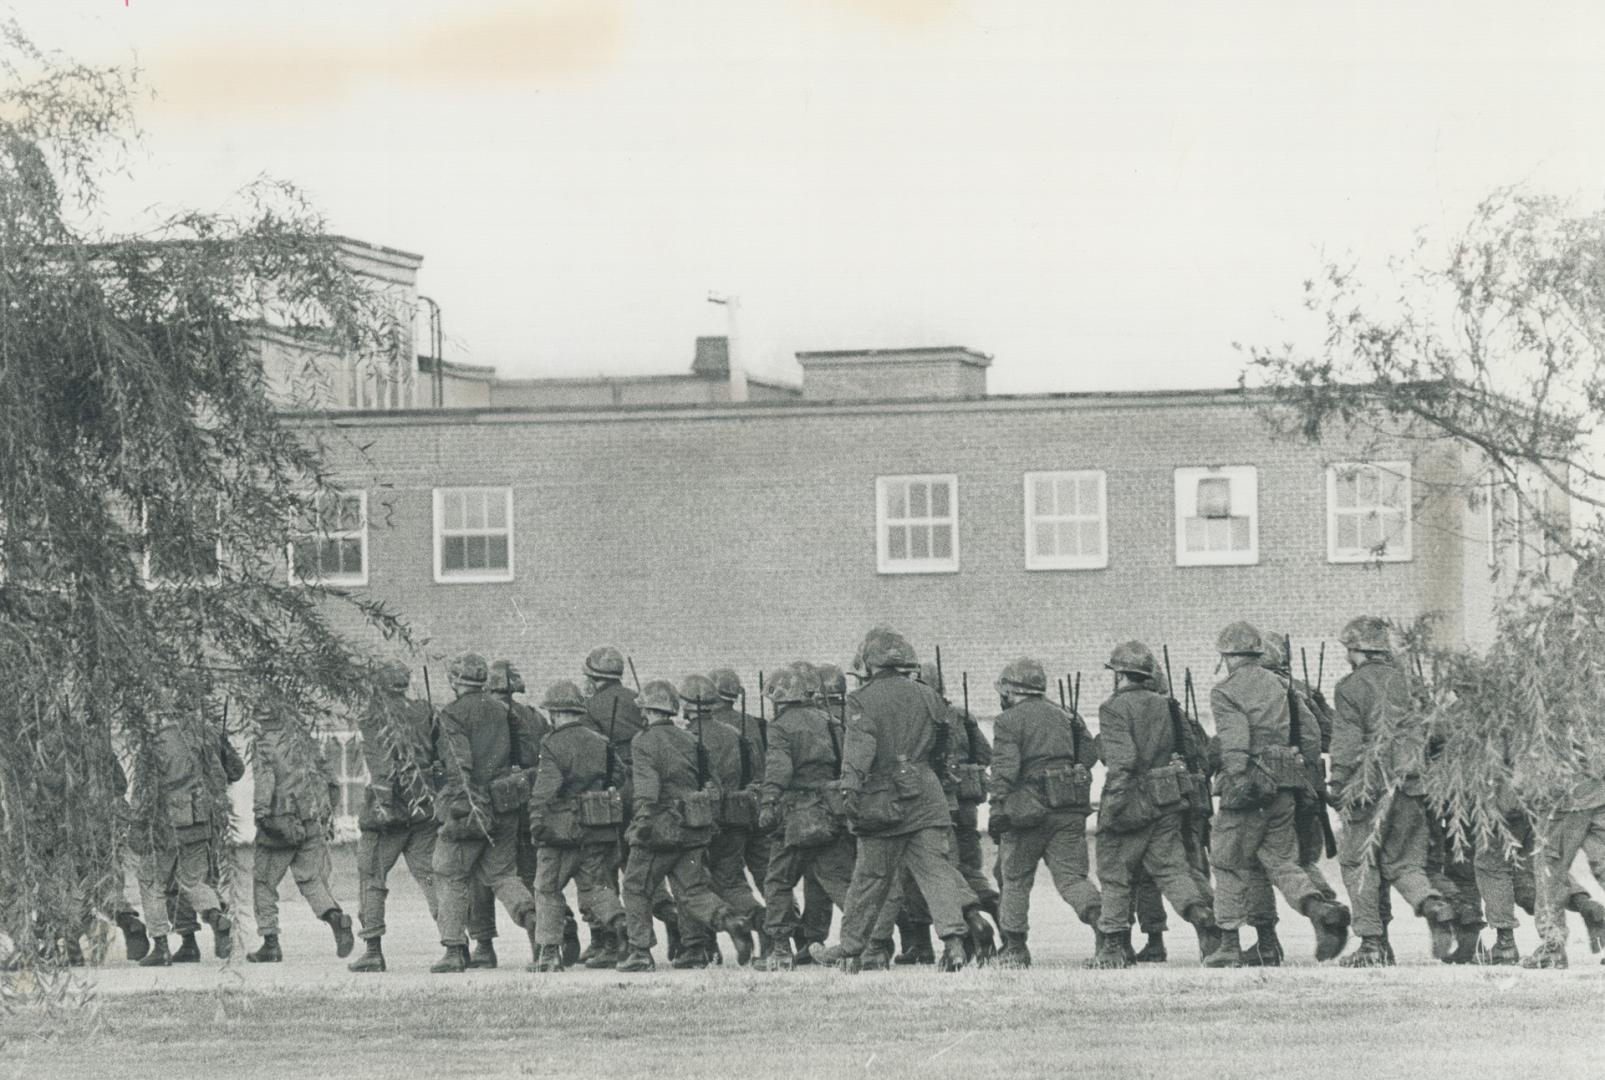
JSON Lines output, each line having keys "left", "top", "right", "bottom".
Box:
{"left": 841, "top": 671, "right": 953, "bottom": 836}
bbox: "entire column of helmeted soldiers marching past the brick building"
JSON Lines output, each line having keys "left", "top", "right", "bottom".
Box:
{"left": 28, "top": 616, "right": 1605, "bottom": 972}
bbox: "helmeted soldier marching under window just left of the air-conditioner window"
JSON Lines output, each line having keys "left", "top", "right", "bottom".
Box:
{"left": 987, "top": 658, "right": 1103, "bottom": 968}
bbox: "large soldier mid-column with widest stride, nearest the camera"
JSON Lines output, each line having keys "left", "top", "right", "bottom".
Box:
{"left": 811, "top": 631, "right": 992, "bottom": 971}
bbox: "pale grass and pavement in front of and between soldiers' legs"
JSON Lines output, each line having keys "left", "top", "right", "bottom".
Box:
{"left": 0, "top": 849, "right": 1605, "bottom": 1080}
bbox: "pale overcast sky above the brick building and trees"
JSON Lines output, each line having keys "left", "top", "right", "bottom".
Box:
{"left": 16, "top": 0, "right": 1605, "bottom": 392}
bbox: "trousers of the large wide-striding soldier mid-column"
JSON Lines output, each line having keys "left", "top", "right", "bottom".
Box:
{"left": 841, "top": 825, "right": 974, "bottom": 956}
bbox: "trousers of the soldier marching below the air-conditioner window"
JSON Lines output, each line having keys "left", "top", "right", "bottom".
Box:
{"left": 1213, "top": 791, "right": 1321, "bottom": 931}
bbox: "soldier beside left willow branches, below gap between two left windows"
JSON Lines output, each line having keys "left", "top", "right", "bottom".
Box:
{"left": 351, "top": 663, "right": 440, "bottom": 972}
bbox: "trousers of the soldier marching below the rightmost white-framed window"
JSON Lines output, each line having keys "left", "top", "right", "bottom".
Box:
{"left": 1337, "top": 793, "right": 1443, "bottom": 937}
